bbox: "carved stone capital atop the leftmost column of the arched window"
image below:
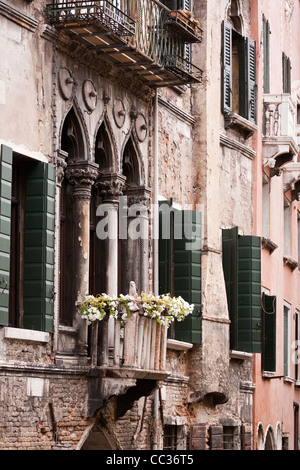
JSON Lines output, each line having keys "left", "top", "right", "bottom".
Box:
{"left": 65, "top": 161, "right": 98, "bottom": 199}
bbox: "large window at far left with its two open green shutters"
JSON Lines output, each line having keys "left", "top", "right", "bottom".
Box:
{"left": 0, "top": 145, "right": 55, "bottom": 331}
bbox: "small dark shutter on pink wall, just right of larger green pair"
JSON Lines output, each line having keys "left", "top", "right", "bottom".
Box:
{"left": 262, "top": 292, "right": 276, "bottom": 372}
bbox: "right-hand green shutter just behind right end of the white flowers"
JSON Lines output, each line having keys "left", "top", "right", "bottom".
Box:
{"left": 174, "top": 210, "right": 201, "bottom": 344}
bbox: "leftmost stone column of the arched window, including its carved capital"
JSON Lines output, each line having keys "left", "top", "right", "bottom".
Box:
{"left": 66, "top": 161, "right": 98, "bottom": 355}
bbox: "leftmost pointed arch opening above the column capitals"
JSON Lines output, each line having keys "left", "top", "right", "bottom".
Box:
{"left": 60, "top": 103, "right": 89, "bottom": 162}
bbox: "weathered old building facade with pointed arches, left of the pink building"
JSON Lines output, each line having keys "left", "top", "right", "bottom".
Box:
{"left": 0, "top": 0, "right": 300, "bottom": 451}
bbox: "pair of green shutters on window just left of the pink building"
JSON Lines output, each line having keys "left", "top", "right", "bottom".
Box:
{"left": 223, "top": 227, "right": 261, "bottom": 353}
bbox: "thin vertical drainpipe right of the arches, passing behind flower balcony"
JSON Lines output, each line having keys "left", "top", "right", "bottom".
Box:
{"left": 152, "top": 88, "right": 159, "bottom": 450}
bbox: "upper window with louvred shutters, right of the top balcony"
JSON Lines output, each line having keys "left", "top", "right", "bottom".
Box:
{"left": 222, "top": 21, "right": 257, "bottom": 123}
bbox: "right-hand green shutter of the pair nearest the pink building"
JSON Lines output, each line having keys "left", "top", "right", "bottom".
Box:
{"left": 238, "top": 236, "right": 261, "bottom": 353}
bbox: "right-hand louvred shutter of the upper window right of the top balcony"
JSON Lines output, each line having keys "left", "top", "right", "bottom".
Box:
{"left": 245, "top": 38, "right": 257, "bottom": 123}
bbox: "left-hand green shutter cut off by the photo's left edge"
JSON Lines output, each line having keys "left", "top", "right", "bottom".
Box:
{"left": 0, "top": 145, "right": 13, "bottom": 326}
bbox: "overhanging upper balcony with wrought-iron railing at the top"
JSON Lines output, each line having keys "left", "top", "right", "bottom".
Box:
{"left": 47, "top": 0, "right": 202, "bottom": 87}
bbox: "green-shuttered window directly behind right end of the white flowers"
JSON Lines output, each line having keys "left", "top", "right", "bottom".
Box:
{"left": 159, "top": 201, "right": 201, "bottom": 343}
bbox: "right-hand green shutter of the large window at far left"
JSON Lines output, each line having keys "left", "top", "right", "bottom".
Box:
{"left": 24, "top": 162, "right": 55, "bottom": 331}
